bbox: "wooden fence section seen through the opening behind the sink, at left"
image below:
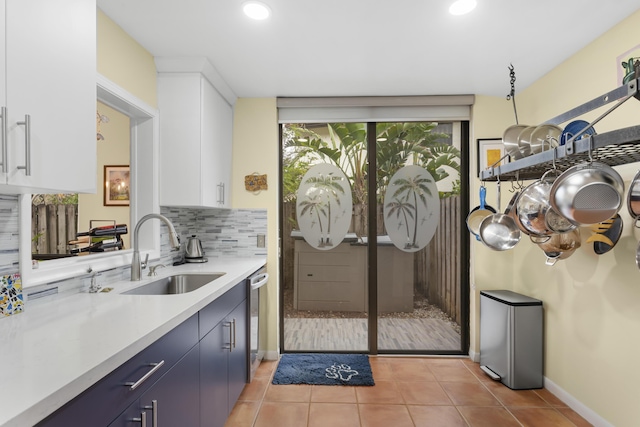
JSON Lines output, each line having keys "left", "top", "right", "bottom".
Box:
{"left": 31, "top": 204, "right": 78, "bottom": 254}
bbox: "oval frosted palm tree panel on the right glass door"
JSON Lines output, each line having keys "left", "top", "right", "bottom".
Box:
{"left": 384, "top": 165, "right": 440, "bottom": 252}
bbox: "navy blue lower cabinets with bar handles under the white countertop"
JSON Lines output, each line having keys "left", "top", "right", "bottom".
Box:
{"left": 36, "top": 281, "right": 248, "bottom": 427}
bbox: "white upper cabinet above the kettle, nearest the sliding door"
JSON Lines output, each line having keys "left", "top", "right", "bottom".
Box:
{"left": 158, "top": 72, "right": 233, "bottom": 208}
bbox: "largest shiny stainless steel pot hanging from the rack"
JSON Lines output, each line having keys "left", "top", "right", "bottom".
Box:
{"left": 550, "top": 162, "right": 624, "bottom": 225}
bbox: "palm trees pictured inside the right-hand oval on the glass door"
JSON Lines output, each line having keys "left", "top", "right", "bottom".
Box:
{"left": 387, "top": 175, "right": 432, "bottom": 249}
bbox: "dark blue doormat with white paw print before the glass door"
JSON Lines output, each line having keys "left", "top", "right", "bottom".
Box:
{"left": 272, "top": 353, "right": 375, "bottom": 386}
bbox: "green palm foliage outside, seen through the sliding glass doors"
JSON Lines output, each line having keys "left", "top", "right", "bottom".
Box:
{"left": 283, "top": 122, "right": 460, "bottom": 204}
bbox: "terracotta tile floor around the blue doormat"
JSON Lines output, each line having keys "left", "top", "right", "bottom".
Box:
{"left": 225, "top": 356, "right": 591, "bottom": 427}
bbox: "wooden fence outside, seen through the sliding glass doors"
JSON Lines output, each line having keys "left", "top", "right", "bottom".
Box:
{"left": 283, "top": 196, "right": 466, "bottom": 324}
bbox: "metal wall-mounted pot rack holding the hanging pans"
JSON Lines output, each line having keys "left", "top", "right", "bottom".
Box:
{"left": 480, "top": 77, "right": 640, "bottom": 181}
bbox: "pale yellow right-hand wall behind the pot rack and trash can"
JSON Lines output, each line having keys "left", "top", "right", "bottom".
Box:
{"left": 471, "top": 12, "right": 640, "bottom": 426}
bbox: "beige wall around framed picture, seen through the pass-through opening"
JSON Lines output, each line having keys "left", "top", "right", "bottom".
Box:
{"left": 78, "top": 102, "right": 133, "bottom": 249}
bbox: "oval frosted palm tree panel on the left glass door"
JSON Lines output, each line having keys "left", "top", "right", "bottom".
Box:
{"left": 296, "top": 163, "right": 353, "bottom": 251}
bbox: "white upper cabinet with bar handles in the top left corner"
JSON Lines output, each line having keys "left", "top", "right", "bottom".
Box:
{"left": 0, "top": 0, "right": 96, "bottom": 193}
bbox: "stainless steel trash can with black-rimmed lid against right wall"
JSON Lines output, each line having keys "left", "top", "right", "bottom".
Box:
{"left": 480, "top": 290, "right": 544, "bottom": 390}
